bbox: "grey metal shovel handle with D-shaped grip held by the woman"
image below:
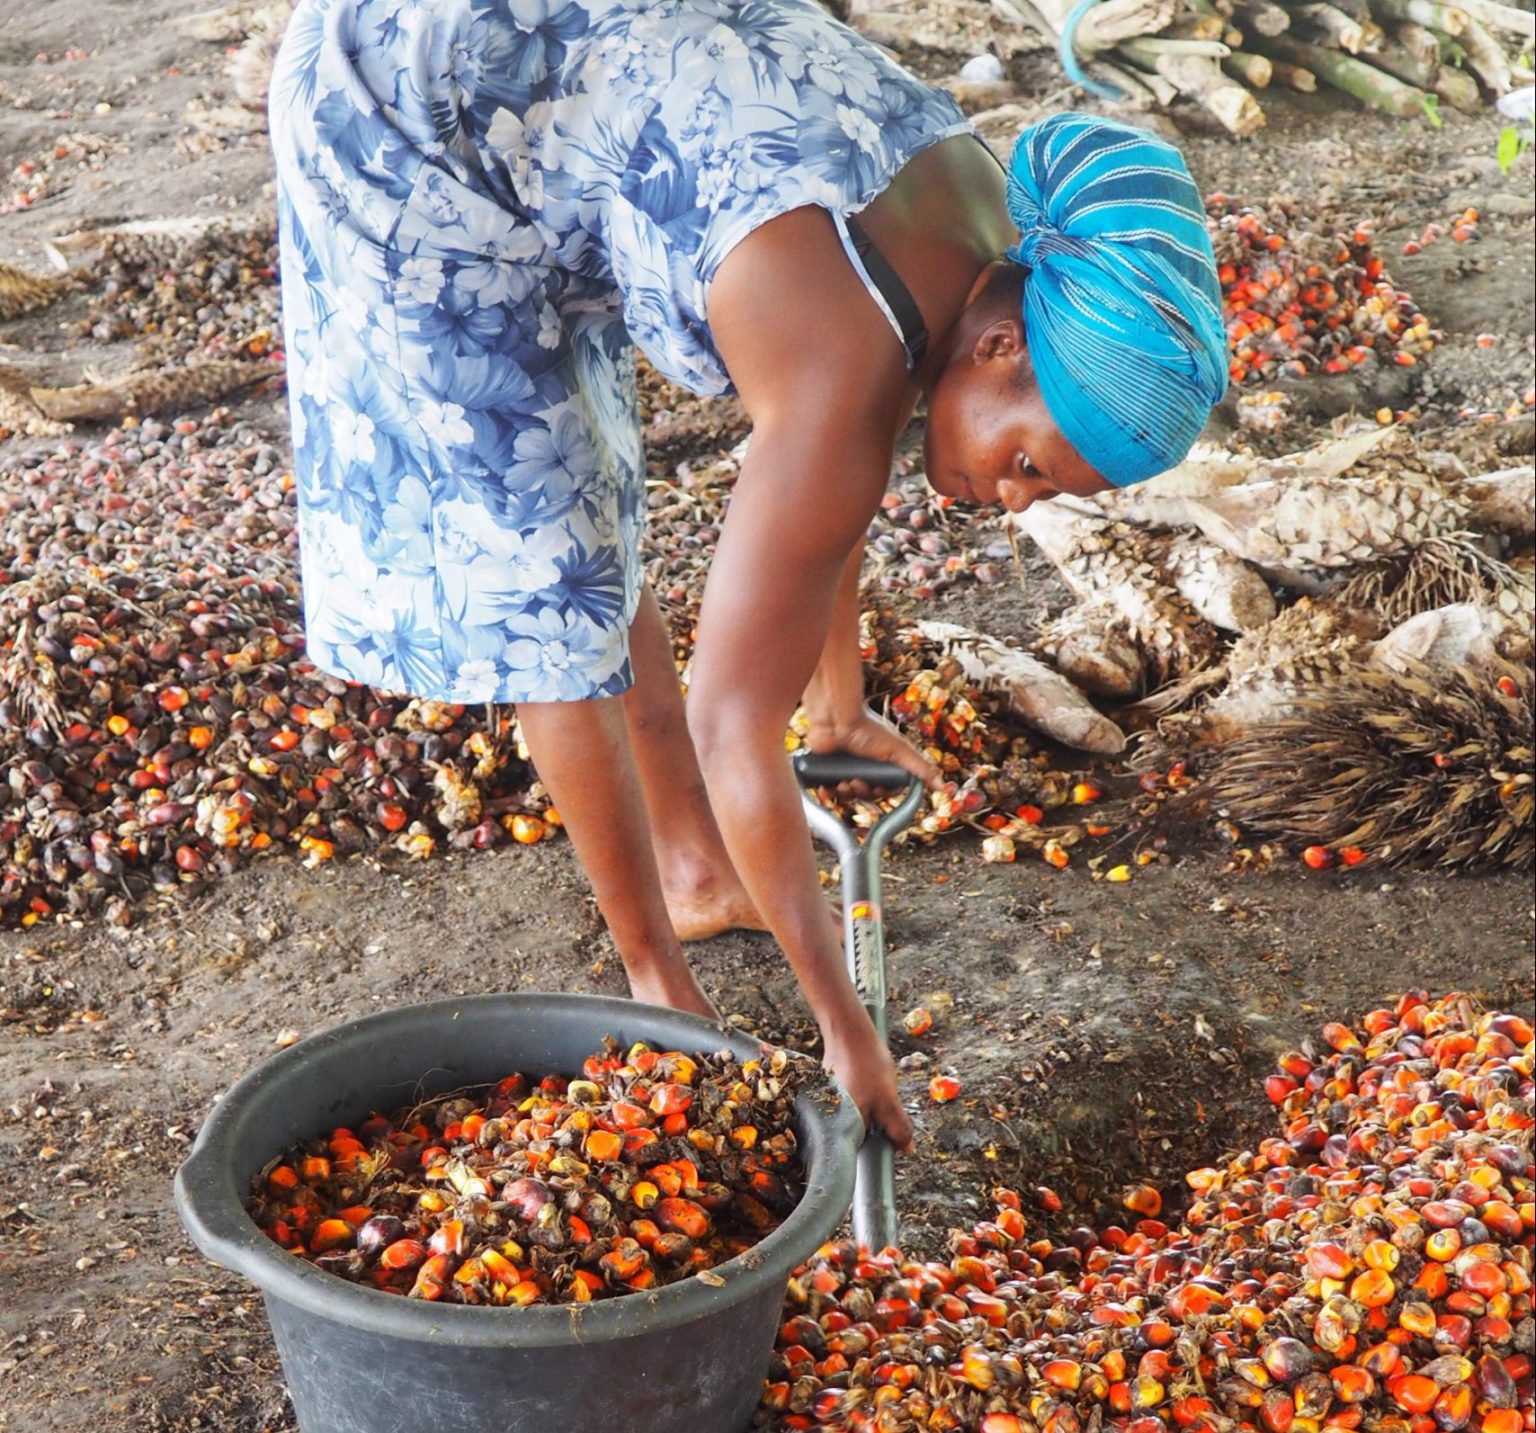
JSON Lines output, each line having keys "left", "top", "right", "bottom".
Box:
{"left": 794, "top": 751, "right": 923, "bottom": 1250}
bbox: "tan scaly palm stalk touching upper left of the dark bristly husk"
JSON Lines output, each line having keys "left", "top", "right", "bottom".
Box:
{"left": 1206, "top": 597, "right": 1379, "bottom": 734}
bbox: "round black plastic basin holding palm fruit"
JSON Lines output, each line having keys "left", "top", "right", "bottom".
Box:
{"left": 177, "top": 995, "right": 862, "bottom": 1433}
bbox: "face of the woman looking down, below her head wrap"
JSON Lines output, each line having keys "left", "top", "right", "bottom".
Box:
{"left": 923, "top": 319, "right": 1112, "bottom": 513}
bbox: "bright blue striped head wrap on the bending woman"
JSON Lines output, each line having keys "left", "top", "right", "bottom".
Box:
{"left": 1008, "top": 114, "right": 1227, "bottom": 487}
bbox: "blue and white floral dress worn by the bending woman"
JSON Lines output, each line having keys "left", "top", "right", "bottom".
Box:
{"left": 270, "top": 0, "right": 968, "bottom": 702}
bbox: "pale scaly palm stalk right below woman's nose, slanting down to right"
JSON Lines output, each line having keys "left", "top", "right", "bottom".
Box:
{"left": 1006, "top": 499, "right": 1220, "bottom": 685}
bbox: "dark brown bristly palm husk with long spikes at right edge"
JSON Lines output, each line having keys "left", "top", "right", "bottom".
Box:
{"left": 1206, "top": 664, "right": 1536, "bottom": 871}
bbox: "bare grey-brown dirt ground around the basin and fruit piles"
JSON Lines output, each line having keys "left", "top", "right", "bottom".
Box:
{"left": 0, "top": 0, "right": 1536, "bottom": 1433}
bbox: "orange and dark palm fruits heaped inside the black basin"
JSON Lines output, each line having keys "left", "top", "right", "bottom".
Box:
{"left": 247, "top": 1043, "right": 820, "bottom": 1307}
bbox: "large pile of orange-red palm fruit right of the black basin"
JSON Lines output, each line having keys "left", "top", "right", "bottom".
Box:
{"left": 756, "top": 994, "right": 1536, "bottom": 1433}
